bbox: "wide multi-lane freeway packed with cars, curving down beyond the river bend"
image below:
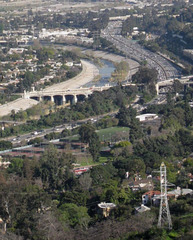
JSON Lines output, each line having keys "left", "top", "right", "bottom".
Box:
{"left": 101, "top": 21, "right": 181, "bottom": 81}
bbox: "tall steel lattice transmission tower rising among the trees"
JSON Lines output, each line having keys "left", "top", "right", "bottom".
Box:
{"left": 157, "top": 162, "right": 172, "bottom": 229}
